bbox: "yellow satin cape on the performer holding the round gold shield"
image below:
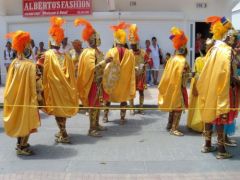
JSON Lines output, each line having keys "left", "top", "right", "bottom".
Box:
{"left": 106, "top": 47, "right": 136, "bottom": 102}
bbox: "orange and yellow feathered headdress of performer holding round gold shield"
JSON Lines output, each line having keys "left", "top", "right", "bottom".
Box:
{"left": 111, "top": 21, "right": 129, "bottom": 44}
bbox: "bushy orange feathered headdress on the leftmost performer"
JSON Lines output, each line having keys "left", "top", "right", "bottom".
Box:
{"left": 5, "top": 30, "right": 31, "bottom": 53}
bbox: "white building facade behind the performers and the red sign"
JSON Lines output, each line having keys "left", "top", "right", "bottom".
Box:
{"left": 0, "top": 0, "right": 239, "bottom": 84}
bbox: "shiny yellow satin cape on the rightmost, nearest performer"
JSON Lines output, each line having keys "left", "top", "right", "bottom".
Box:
{"left": 197, "top": 41, "right": 232, "bottom": 123}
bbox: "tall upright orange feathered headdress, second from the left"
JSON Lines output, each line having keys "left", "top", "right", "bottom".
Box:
{"left": 48, "top": 16, "right": 65, "bottom": 46}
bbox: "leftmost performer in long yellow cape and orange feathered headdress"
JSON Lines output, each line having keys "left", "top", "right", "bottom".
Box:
{"left": 3, "top": 31, "right": 40, "bottom": 155}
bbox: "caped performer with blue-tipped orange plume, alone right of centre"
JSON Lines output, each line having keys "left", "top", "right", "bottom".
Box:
{"left": 158, "top": 27, "right": 191, "bottom": 136}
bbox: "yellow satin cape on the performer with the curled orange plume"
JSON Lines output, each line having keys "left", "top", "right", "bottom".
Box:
{"left": 77, "top": 48, "right": 96, "bottom": 106}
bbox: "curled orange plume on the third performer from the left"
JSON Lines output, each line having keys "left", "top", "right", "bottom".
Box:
{"left": 74, "top": 18, "right": 95, "bottom": 41}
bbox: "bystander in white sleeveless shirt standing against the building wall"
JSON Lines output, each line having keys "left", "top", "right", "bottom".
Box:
{"left": 151, "top": 37, "right": 163, "bottom": 85}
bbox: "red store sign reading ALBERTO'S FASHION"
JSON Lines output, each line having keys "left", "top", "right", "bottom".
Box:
{"left": 23, "top": 0, "right": 92, "bottom": 17}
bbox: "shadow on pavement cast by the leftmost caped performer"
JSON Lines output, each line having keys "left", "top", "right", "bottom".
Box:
{"left": 19, "top": 145, "right": 78, "bottom": 160}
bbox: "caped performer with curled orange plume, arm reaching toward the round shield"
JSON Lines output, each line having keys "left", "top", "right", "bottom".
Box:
{"left": 74, "top": 18, "right": 112, "bottom": 137}
